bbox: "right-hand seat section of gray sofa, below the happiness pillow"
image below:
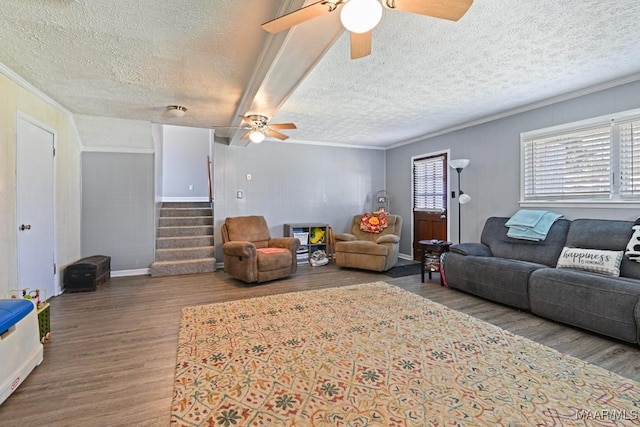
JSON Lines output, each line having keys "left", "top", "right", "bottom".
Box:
{"left": 528, "top": 268, "right": 640, "bottom": 343}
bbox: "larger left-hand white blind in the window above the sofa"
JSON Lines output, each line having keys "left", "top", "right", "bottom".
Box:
{"left": 523, "top": 125, "right": 612, "bottom": 199}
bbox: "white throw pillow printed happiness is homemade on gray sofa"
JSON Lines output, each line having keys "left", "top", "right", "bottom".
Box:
{"left": 556, "top": 246, "right": 624, "bottom": 276}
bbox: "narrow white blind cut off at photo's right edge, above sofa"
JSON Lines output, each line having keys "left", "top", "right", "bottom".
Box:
{"left": 619, "top": 120, "right": 640, "bottom": 197}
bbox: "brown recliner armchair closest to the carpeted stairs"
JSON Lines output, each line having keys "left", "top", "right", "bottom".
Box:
{"left": 222, "top": 216, "right": 300, "bottom": 283}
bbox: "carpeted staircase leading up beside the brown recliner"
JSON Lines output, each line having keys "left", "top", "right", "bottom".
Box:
{"left": 150, "top": 202, "right": 216, "bottom": 277}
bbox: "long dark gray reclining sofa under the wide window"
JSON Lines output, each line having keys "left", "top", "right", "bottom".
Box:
{"left": 442, "top": 217, "right": 640, "bottom": 344}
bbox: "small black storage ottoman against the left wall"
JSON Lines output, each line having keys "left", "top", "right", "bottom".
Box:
{"left": 63, "top": 255, "right": 111, "bottom": 292}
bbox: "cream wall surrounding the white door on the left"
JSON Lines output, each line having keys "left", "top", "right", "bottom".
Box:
{"left": 0, "top": 71, "right": 80, "bottom": 297}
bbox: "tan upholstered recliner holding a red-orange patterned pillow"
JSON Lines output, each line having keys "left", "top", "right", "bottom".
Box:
{"left": 334, "top": 214, "right": 402, "bottom": 271}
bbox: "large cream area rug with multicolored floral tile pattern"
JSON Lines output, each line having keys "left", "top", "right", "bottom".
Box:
{"left": 171, "top": 282, "right": 640, "bottom": 427}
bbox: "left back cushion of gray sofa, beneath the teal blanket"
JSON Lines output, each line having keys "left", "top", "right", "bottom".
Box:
{"left": 480, "top": 217, "right": 568, "bottom": 267}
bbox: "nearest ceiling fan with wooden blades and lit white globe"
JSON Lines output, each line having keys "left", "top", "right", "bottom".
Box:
{"left": 262, "top": 0, "right": 473, "bottom": 59}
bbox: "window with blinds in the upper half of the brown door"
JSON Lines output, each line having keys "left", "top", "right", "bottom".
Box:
{"left": 413, "top": 154, "right": 447, "bottom": 212}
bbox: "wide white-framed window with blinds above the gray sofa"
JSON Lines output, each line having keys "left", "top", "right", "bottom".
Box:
{"left": 521, "top": 112, "right": 640, "bottom": 201}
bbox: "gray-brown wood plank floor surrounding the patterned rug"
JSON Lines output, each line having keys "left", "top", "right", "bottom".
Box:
{"left": 0, "top": 265, "right": 640, "bottom": 427}
